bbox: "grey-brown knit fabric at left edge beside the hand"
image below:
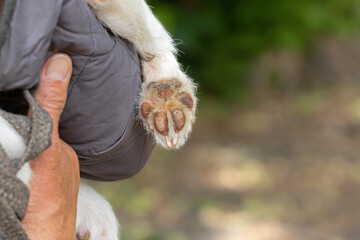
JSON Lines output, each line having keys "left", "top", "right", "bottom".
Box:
{"left": 0, "top": 90, "right": 52, "bottom": 240}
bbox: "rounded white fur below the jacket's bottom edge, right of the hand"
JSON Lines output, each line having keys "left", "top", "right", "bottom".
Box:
{"left": 76, "top": 184, "right": 119, "bottom": 240}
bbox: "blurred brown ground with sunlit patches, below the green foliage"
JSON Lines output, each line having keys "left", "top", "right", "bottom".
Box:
{"left": 88, "top": 85, "right": 360, "bottom": 240}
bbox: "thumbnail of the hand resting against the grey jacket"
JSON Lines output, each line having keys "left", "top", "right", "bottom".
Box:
{"left": 45, "top": 54, "right": 71, "bottom": 81}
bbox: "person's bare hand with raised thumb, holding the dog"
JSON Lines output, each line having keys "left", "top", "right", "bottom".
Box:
{"left": 22, "top": 54, "right": 80, "bottom": 240}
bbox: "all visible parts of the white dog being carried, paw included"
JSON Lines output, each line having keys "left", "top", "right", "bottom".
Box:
{"left": 0, "top": 0, "right": 197, "bottom": 240}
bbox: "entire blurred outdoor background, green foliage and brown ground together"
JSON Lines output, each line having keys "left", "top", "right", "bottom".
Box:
{"left": 91, "top": 0, "right": 360, "bottom": 240}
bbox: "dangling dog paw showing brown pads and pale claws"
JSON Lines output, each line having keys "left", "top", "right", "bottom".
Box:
{"left": 139, "top": 78, "right": 196, "bottom": 149}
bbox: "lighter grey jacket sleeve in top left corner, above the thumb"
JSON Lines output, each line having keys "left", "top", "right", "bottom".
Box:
{"left": 0, "top": 0, "right": 63, "bottom": 91}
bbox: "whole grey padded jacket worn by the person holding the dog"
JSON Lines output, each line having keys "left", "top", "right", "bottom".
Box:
{"left": 0, "top": 0, "right": 154, "bottom": 181}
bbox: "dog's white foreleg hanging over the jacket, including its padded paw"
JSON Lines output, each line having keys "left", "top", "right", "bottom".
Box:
{"left": 86, "top": 0, "right": 197, "bottom": 148}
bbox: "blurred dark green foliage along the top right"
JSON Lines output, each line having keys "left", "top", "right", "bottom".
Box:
{"left": 149, "top": 0, "right": 360, "bottom": 100}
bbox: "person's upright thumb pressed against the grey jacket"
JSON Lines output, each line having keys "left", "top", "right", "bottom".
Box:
{"left": 34, "top": 53, "right": 72, "bottom": 126}
